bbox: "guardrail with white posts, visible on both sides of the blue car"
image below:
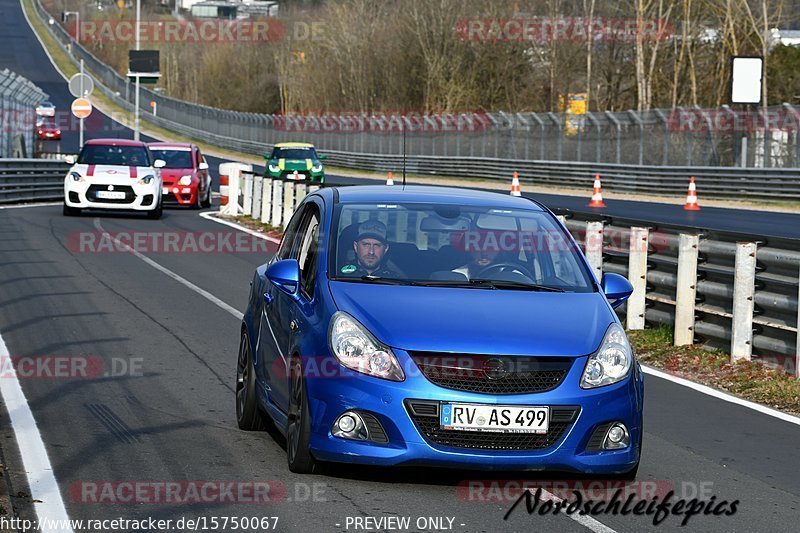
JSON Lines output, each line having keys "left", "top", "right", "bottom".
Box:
{"left": 225, "top": 172, "right": 800, "bottom": 377}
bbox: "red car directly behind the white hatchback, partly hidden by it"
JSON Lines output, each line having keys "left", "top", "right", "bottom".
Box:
{"left": 147, "top": 143, "right": 211, "bottom": 209}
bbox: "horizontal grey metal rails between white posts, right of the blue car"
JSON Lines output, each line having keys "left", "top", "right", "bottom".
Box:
{"left": 563, "top": 212, "right": 800, "bottom": 377}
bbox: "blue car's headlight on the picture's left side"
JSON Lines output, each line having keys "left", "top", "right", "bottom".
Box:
{"left": 329, "top": 311, "right": 405, "bottom": 381}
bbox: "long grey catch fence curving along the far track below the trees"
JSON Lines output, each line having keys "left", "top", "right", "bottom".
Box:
{"left": 34, "top": 0, "right": 800, "bottom": 168}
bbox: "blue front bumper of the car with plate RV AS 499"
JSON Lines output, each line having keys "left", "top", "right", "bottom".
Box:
{"left": 306, "top": 351, "right": 643, "bottom": 474}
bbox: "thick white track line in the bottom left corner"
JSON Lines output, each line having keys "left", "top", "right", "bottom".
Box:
{"left": 0, "top": 335, "right": 73, "bottom": 533}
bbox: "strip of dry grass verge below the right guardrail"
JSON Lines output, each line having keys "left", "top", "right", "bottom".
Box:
{"left": 628, "top": 327, "right": 800, "bottom": 415}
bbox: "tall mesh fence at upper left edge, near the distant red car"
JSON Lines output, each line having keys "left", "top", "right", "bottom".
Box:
{"left": 0, "top": 69, "right": 47, "bottom": 157}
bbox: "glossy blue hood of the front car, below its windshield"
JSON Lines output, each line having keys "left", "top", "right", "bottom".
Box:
{"left": 330, "top": 281, "right": 614, "bottom": 356}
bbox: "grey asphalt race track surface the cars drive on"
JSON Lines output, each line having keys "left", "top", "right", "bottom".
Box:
{"left": 0, "top": 0, "right": 800, "bottom": 532}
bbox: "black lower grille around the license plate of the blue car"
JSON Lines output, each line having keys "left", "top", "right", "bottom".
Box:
{"left": 405, "top": 400, "right": 580, "bottom": 450}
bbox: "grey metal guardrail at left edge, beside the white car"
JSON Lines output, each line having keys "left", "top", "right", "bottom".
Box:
{"left": 0, "top": 159, "right": 70, "bottom": 204}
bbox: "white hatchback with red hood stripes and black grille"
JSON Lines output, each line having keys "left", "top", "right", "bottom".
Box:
{"left": 64, "top": 139, "right": 165, "bottom": 218}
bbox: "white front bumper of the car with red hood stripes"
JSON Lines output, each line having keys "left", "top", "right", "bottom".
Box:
{"left": 64, "top": 176, "right": 161, "bottom": 211}
